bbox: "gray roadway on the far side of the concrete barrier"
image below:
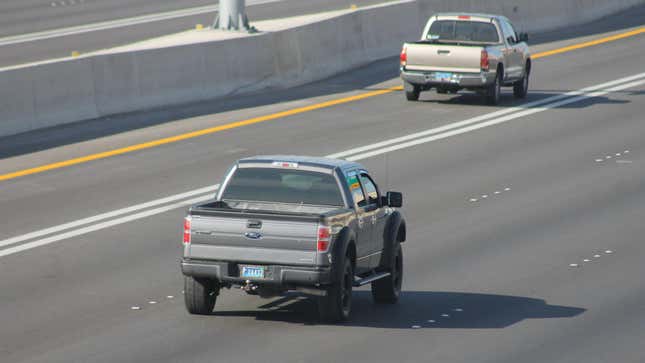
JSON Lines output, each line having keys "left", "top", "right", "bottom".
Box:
{"left": 0, "top": 0, "right": 390, "bottom": 67}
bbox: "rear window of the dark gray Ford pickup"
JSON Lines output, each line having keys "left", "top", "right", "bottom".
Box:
{"left": 221, "top": 168, "right": 344, "bottom": 206}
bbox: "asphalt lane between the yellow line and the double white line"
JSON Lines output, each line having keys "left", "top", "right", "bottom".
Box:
{"left": 0, "top": 28, "right": 642, "bottom": 243}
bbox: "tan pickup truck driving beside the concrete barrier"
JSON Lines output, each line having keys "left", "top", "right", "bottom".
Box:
{"left": 400, "top": 13, "right": 531, "bottom": 104}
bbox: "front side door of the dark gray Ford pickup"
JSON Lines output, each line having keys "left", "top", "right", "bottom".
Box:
{"left": 359, "top": 170, "right": 387, "bottom": 268}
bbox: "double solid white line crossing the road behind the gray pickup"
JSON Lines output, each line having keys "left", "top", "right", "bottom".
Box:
{"left": 0, "top": 73, "right": 645, "bottom": 257}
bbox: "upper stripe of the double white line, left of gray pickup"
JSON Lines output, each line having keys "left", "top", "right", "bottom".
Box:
{"left": 0, "top": 184, "right": 219, "bottom": 247}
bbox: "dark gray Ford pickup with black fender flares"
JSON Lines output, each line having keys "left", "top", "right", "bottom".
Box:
{"left": 181, "top": 156, "right": 406, "bottom": 322}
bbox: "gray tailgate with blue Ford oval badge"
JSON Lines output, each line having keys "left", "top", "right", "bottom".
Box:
{"left": 185, "top": 213, "right": 318, "bottom": 265}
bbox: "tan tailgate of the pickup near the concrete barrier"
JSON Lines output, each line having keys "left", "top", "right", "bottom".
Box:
{"left": 405, "top": 43, "right": 483, "bottom": 73}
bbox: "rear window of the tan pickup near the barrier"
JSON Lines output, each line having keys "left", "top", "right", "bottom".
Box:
{"left": 427, "top": 20, "right": 499, "bottom": 43}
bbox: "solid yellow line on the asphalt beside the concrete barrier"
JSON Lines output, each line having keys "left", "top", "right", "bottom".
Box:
{"left": 0, "top": 27, "right": 645, "bottom": 181}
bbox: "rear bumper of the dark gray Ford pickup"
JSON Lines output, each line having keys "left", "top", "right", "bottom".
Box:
{"left": 181, "top": 259, "right": 331, "bottom": 287}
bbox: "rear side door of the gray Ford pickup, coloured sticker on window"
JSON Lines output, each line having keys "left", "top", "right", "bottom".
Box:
{"left": 346, "top": 170, "right": 372, "bottom": 273}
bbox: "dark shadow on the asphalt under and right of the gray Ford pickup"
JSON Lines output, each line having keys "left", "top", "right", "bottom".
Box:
{"left": 214, "top": 291, "right": 585, "bottom": 329}
